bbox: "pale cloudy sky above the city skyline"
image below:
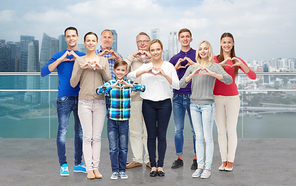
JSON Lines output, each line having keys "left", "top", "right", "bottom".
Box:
{"left": 0, "top": 0, "right": 296, "bottom": 60}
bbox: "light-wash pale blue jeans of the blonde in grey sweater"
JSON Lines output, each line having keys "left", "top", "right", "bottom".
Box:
{"left": 190, "top": 103, "right": 216, "bottom": 170}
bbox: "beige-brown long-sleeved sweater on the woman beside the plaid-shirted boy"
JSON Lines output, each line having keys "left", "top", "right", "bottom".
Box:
{"left": 70, "top": 56, "right": 111, "bottom": 100}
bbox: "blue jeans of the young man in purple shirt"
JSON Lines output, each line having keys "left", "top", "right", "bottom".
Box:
{"left": 173, "top": 94, "right": 196, "bottom": 156}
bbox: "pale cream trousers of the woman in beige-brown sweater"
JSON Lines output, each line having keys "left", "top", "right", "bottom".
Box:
{"left": 78, "top": 100, "right": 106, "bottom": 171}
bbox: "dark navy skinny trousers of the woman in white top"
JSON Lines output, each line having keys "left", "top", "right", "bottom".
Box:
{"left": 142, "top": 99, "right": 172, "bottom": 167}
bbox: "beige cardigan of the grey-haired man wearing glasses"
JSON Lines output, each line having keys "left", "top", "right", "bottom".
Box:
{"left": 125, "top": 55, "right": 153, "bottom": 101}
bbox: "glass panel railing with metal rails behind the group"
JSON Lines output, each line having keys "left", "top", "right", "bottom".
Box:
{"left": 0, "top": 72, "right": 296, "bottom": 138}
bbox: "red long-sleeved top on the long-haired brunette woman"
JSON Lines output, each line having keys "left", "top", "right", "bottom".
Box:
{"left": 213, "top": 56, "right": 256, "bottom": 96}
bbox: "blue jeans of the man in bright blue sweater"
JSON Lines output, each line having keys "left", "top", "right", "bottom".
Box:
{"left": 57, "top": 96, "right": 83, "bottom": 165}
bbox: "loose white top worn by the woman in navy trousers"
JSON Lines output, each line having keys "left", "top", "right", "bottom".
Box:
{"left": 127, "top": 61, "right": 180, "bottom": 101}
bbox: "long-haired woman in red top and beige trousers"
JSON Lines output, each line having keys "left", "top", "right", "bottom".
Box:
{"left": 214, "top": 33, "right": 256, "bottom": 171}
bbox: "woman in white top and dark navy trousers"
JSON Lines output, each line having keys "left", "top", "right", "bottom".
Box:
{"left": 128, "top": 39, "right": 179, "bottom": 177}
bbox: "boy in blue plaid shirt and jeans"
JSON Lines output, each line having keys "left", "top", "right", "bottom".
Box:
{"left": 96, "top": 60, "right": 145, "bottom": 179}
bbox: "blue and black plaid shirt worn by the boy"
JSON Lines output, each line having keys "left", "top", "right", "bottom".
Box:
{"left": 96, "top": 78, "right": 145, "bottom": 121}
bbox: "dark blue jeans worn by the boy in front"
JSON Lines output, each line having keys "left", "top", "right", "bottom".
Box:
{"left": 107, "top": 118, "right": 129, "bottom": 172}
